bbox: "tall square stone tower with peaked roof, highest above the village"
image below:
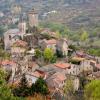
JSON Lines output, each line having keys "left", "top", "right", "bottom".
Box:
{"left": 28, "top": 9, "right": 38, "bottom": 27}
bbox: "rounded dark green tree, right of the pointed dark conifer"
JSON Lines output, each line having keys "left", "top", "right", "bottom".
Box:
{"left": 34, "top": 77, "right": 48, "bottom": 95}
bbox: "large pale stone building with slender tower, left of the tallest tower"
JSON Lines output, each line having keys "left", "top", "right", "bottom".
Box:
{"left": 4, "top": 22, "right": 26, "bottom": 51}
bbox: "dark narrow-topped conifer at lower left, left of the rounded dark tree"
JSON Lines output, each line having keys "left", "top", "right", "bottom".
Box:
{"left": 14, "top": 74, "right": 29, "bottom": 97}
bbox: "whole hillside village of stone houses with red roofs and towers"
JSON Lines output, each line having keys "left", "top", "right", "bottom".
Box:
{"left": 0, "top": 9, "right": 100, "bottom": 100}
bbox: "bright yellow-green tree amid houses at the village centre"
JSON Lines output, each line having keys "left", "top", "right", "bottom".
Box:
{"left": 43, "top": 48, "right": 54, "bottom": 62}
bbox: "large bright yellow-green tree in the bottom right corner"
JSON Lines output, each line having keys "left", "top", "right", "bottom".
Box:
{"left": 84, "top": 80, "right": 100, "bottom": 100}
